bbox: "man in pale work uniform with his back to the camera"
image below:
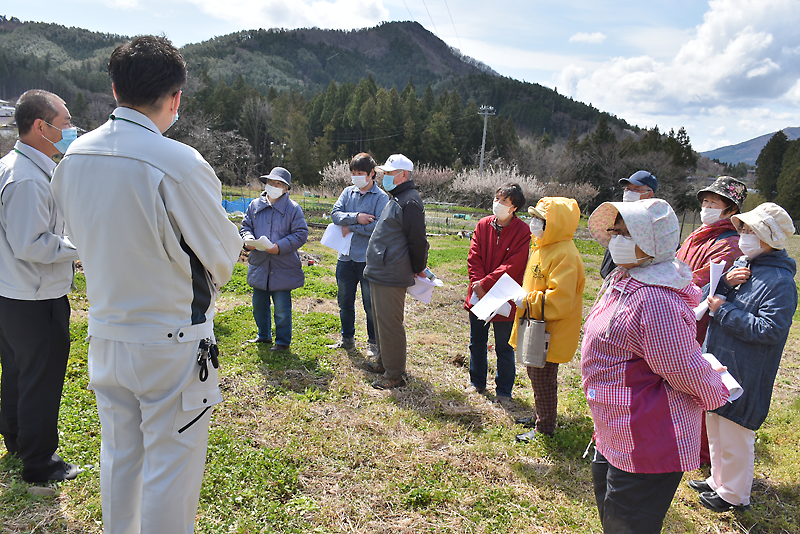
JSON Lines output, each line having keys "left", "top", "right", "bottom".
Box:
{"left": 52, "top": 36, "right": 242, "bottom": 534}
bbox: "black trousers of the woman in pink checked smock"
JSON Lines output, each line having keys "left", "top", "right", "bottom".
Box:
{"left": 592, "top": 450, "right": 683, "bottom": 534}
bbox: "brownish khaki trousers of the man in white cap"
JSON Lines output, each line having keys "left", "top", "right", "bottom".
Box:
{"left": 369, "top": 281, "right": 406, "bottom": 380}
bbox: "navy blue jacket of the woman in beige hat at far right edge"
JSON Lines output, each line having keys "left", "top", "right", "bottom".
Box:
{"left": 703, "top": 250, "right": 797, "bottom": 430}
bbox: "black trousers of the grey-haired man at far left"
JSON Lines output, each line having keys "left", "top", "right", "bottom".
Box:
{"left": 0, "top": 296, "right": 70, "bottom": 479}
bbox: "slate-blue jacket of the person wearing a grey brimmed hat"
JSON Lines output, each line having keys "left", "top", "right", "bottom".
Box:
{"left": 240, "top": 193, "right": 308, "bottom": 291}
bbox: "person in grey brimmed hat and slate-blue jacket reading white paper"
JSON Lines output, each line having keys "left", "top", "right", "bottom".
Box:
{"left": 240, "top": 167, "right": 308, "bottom": 351}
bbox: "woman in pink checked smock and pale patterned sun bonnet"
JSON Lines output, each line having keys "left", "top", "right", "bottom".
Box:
{"left": 581, "top": 199, "right": 728, "bottom": 534}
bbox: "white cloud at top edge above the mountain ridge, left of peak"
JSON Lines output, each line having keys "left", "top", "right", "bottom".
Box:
{"left": 185, "top": 0, "right": 389, "bottom": 29}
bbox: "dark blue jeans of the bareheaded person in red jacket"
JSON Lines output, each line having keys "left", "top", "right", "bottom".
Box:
{"left": 469, "top": 313, "right": 517, "bottom": 397}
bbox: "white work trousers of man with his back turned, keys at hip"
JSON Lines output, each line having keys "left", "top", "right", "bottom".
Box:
{"left": 89, "top": 337, "right": 222, "bottom": 534}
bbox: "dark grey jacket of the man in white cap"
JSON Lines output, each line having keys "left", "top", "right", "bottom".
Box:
{"left": 364, "top": 181, "right": 428, "bottom": 287}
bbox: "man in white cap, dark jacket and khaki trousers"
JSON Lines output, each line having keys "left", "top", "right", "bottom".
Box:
{"left": 364, "top": 154, "right": 428, "bottom": 389}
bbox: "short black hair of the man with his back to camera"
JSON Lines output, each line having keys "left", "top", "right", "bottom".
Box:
{"left": 108, "top": 35, "right": 187, "bottom": 107}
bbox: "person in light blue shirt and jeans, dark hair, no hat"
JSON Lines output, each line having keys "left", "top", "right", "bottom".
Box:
{"left": 328, "top": 152, "right": 389, "bottom": 358}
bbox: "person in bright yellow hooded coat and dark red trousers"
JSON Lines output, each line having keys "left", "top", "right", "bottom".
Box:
{"left": 511, "top": 197, "right": 585, "bottom": 442}
